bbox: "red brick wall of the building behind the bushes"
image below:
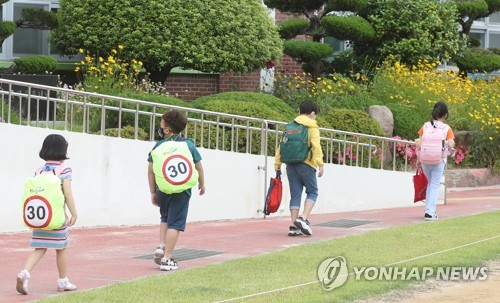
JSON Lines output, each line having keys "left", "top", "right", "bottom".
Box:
{"left": 165, "top": 11, "right": 306, "bottom": 101}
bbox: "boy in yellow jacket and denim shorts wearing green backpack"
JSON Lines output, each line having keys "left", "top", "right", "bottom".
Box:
{"left": 274, "top": 100, "right": 324, "bottom": 236}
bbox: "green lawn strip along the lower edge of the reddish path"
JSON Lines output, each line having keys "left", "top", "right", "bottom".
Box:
{"left": 40, "top": 211, "right": 500, "bottom": 303}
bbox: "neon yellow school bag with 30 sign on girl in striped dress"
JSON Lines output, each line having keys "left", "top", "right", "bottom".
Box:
{"left": 21, "top": 170, "right": 66, "bottom": 230}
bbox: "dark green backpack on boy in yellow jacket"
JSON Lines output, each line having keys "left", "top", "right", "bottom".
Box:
{"left": 280, "top": 120, "right": 311, "bottom": 163}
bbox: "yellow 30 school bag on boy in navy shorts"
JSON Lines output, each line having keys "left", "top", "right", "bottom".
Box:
{"left": 151, "top": 138, "right": 198, "bottom": 194}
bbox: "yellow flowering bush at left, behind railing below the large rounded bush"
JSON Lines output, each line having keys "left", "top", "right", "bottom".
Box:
{"left": 75, "top": 45, "right": 142, "bottom": 94}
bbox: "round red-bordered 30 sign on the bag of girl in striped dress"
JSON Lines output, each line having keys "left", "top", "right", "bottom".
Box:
{"left": 23, "top": 195, "right": 52, "bottom": 228}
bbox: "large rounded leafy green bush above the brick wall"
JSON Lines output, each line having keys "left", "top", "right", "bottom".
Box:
{"left": 50, "top": 0, "right": 282, "bottom": 81}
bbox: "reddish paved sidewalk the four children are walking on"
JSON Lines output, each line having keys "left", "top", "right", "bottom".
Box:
{"left": 0, "top": 186, "right": 500, "bottom": 303}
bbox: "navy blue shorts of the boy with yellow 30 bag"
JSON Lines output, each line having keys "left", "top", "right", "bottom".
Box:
{"left": 156, "top": 190, "right": 191, "bottom": 231}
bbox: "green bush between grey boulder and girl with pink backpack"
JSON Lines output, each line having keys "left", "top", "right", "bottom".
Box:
{"left": 387, "top": 103, "right": 429, "bottom": 140}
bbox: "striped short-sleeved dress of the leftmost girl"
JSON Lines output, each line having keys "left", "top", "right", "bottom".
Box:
{"left": 30, "top": 161, "right": 73, "bottom": 249}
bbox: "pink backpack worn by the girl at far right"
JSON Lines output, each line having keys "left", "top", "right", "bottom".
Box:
{"left": 420, "top": 121, "right": 449, "bottom": 165}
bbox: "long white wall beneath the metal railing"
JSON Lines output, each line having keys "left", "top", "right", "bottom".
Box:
{"left": 0, "top": 123, "right": 442, "bottom": 232}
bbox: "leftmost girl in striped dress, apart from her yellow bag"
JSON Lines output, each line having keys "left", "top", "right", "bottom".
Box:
{"left": 16, "top": 134, "right": 77, "bottom": 295}
